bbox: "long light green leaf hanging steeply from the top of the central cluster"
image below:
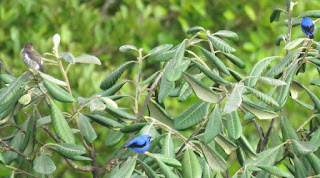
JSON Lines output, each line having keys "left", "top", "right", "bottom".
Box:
{"left": 165, "top": 40, "right": 187, "bottom": 82}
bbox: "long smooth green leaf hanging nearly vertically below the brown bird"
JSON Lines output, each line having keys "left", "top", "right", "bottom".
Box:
{"left": 50, "top": 100, "right": 75, "bottom": 144}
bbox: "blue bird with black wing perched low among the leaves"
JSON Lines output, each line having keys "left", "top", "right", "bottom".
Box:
{"left": 126, "top": 134, "right": 151, "bottom": 153}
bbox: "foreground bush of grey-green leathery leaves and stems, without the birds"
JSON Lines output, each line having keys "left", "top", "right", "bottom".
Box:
{"left": 0, "top": 0, "right": 320, "bottom": 177}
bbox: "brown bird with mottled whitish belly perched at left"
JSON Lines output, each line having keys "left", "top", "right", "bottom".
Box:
{"left": 21, "top": 43, "right": 44, "bottom": 72}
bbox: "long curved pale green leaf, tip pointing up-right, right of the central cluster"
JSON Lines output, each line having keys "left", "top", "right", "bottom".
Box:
{"left": 244, "top": 56, "right": 279, "bottom": 87}
